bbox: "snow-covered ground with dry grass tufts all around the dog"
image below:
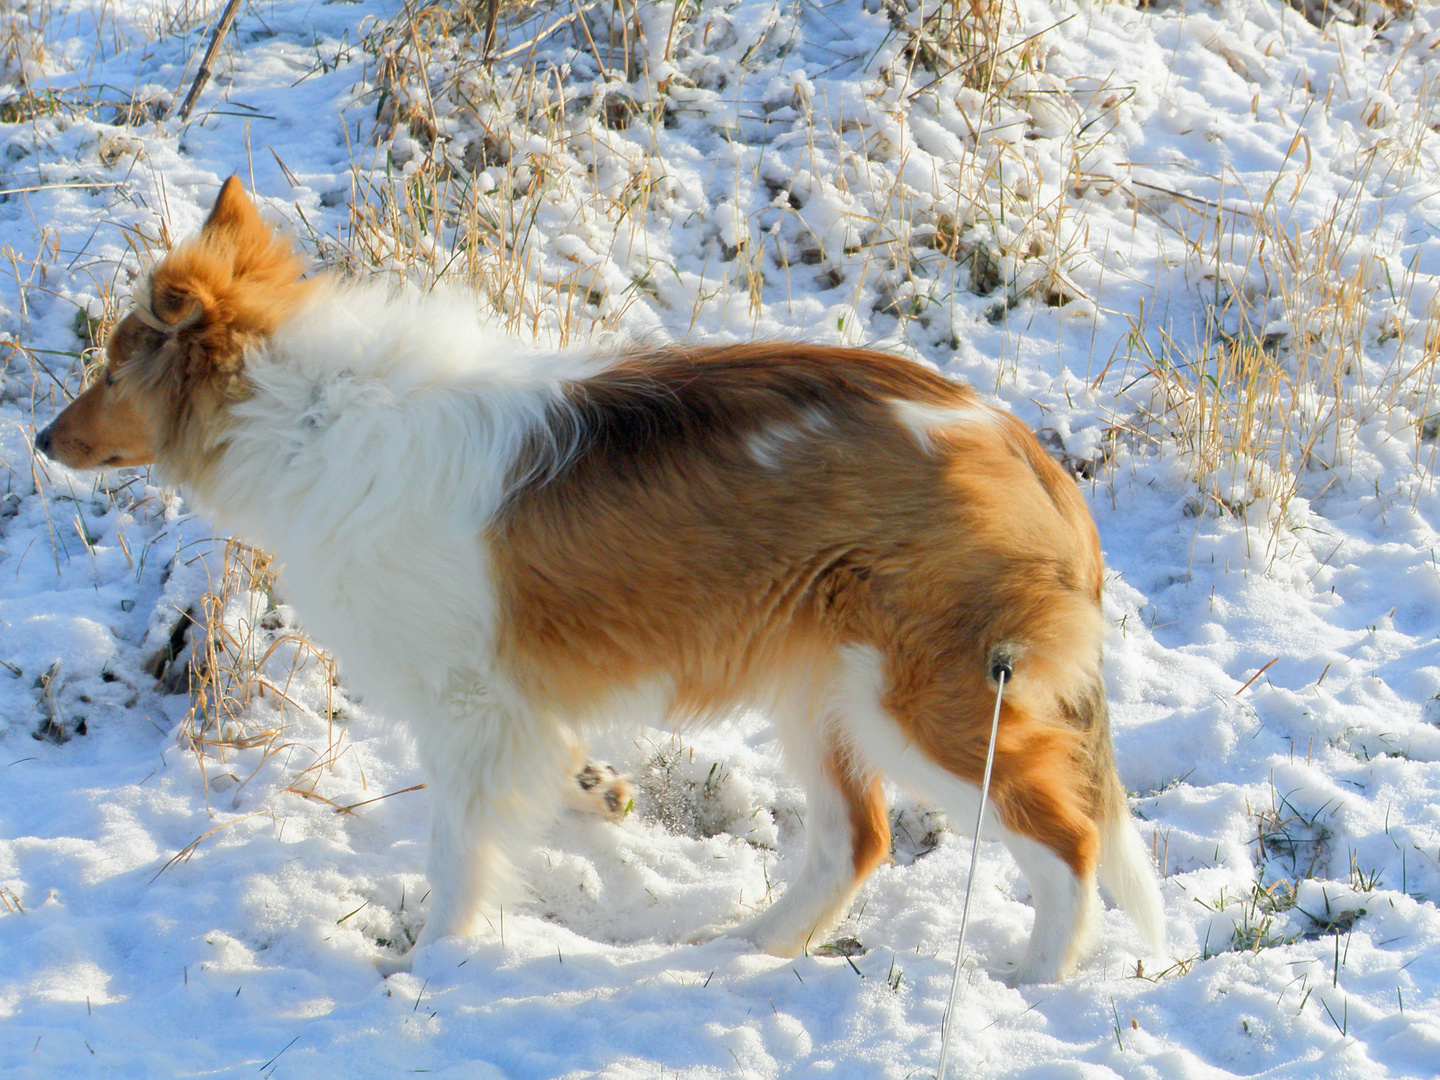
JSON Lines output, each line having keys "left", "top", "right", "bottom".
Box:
{"left": 0, "top": 0, "right": 1440, "bottom": 1080}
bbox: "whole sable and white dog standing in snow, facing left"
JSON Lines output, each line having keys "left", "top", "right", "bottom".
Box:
{"left": 36, "top": 177, "right": 1162, "bottom": 981}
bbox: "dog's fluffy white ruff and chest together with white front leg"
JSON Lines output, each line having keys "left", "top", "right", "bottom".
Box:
{"left": 178, "top": 287, "right": 611, "bottom": 961}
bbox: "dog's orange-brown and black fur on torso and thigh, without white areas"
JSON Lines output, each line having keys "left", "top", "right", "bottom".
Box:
{"left": 494, "top": 344, "right": 1109, "bottom": 877}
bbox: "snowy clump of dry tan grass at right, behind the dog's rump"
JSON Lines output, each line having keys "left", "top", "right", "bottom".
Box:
{"left": 1132, "top": 135, "right": 1440, "bottom": 552}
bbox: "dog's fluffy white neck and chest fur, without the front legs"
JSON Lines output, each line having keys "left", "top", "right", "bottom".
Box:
{"left": 185, "top": 291, "right": 595, "bottom": 711}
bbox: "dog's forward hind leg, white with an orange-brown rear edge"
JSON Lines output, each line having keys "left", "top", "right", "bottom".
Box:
{"left": 727, "top": 705, "right": 890, "bottom": 956}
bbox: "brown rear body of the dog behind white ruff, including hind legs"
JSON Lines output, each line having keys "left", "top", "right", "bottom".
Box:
{"left": 491, "top": 343, "right": 1158, "bottom": 978}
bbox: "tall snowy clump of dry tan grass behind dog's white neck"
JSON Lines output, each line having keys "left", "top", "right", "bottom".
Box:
{"left": 333, "top": 4, "right": 644, "bottom": 344}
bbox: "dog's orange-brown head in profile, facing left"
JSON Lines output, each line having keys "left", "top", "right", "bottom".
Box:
{"left": 35, "top": 176, "right": 310, "bottom": 480}
